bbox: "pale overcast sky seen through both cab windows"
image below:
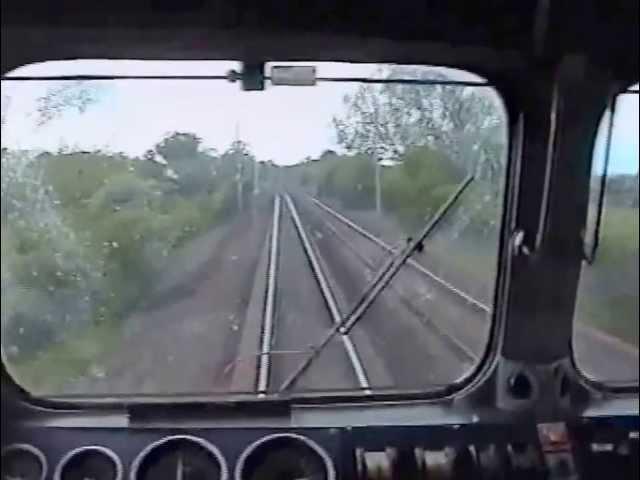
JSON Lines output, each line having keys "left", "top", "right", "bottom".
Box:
{"left": 2, "top": 60, "right": 638, "bottom": 172}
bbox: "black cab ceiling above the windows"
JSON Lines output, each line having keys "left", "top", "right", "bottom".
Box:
{"left": 2, "top": 0, "right": 639, "bottom": 78}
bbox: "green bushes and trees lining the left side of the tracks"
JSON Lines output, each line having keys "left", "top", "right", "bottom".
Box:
{"left": 2, "top": 132, "right": 264, "bottom": 356}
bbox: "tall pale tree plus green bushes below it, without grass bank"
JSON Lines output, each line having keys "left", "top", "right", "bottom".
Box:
{"left": 294, "top": 66, "right": 506, "bottom": 236}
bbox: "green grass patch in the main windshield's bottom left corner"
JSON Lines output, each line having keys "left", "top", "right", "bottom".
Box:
{"left": 7, "top": 322, "right": 121, "bottom": 396}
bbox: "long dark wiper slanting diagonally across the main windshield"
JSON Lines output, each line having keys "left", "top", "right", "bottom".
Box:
{"left": 280, "top": 175, "right": 474, "bottom": 392}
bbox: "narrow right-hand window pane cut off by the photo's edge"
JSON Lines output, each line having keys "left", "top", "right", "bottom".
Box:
{"left": 573, "top": 84, "right": 640, "bottom": 384}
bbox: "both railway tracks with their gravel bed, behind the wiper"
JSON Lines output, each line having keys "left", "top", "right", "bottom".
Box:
{"left": 240, "top": 189, "right": 630, "bottom": 396}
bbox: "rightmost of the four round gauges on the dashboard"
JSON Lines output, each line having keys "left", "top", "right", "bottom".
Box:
{"left": 235, "top": 434, "right": 336, "bottom": 480}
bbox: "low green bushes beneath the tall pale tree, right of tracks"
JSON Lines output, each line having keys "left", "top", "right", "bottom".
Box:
{"left": 289, "top": 146, "right": 502, "bottom": 246}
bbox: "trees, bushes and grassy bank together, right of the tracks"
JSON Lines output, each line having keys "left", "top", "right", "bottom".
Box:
{"left": 289, "top": 66, "right": 507, "bottom": 302}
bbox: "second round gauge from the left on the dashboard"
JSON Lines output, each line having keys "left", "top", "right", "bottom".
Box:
{"left": 54, "top": 446, "right": 122, "bottom": 480}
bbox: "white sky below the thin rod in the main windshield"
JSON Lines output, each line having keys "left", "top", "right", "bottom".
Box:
{"left": 2, "top": 80, "right": 358, "bottom": 164}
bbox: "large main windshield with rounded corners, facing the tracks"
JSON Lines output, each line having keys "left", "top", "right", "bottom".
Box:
{"left": 2, "top": 61, "right": 507, "bottom": 397}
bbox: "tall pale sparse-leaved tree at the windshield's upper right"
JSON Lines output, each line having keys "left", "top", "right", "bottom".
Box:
{"left": 333, "top": 67, "right": 505, "bottom": 181}
